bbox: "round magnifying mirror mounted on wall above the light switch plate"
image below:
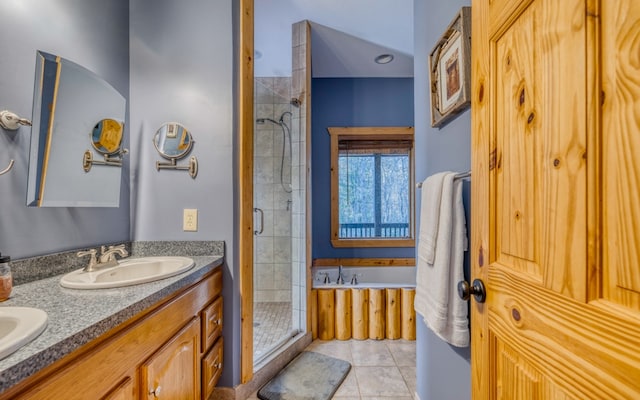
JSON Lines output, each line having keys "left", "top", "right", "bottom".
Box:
{"left": 153, "top": 122, "right": 198, "bottom": 179}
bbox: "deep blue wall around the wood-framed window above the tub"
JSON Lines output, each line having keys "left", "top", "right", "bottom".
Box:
{"left": 311, "top": 78, "right": 415, "bottom": 258}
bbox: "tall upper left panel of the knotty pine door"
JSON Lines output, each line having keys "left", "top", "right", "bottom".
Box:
{"left": 493, "top": 3, "right": 543, "bottom": 281}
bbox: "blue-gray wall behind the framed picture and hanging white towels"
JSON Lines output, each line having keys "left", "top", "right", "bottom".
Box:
{"left": 414, "top": 0, "right": 471, "bottom": 400}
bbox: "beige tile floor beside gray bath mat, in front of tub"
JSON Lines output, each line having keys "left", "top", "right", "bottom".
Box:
{"left": 249, "top": 340, "right": 416, "bottom": 400}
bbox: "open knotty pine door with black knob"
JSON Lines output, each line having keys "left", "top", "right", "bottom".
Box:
{"left": 471, "top": 0, "right": 640, "bottom": 400}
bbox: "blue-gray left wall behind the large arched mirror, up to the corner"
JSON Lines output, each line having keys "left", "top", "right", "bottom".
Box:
{"left": 0, "top": 0, "right": 130, "bottom": 259}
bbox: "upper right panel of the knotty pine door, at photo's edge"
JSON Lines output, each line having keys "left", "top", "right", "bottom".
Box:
{"left": 602, "top": 0, "right": 640, "bottom": 311}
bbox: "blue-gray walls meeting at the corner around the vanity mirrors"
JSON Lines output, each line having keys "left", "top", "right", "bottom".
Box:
{"left": 0, "top": 0, "right": 240, "bottom": 386}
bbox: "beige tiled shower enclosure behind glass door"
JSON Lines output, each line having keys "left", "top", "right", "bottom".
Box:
{"left": 253, "top": 77, "right": 303, "bottom": 365}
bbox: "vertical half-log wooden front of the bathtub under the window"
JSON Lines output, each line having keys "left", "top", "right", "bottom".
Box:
{"left": 311, "top": 287, "right": 416, "bottom": 340}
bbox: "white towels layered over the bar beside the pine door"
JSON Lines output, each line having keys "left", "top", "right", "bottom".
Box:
{"left": 414, "top": 172, "right": 469, "bottom": 347}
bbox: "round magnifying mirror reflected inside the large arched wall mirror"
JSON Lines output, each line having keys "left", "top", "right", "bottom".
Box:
{"left": 82, "top": 118, "right": 129, "bottom": 172}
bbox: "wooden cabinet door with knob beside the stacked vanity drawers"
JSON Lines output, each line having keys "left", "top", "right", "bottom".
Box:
{"left": 140, "top": 318, "right": 200, "bottom": 400}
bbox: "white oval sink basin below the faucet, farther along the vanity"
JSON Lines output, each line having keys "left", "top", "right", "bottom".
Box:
{"left": 60, "top": 257, "right": 195, "bottom": 289}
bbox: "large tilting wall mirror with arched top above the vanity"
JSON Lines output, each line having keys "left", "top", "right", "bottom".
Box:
{"left": 27, "top": 51, "right": 126, "bottom": 207}
